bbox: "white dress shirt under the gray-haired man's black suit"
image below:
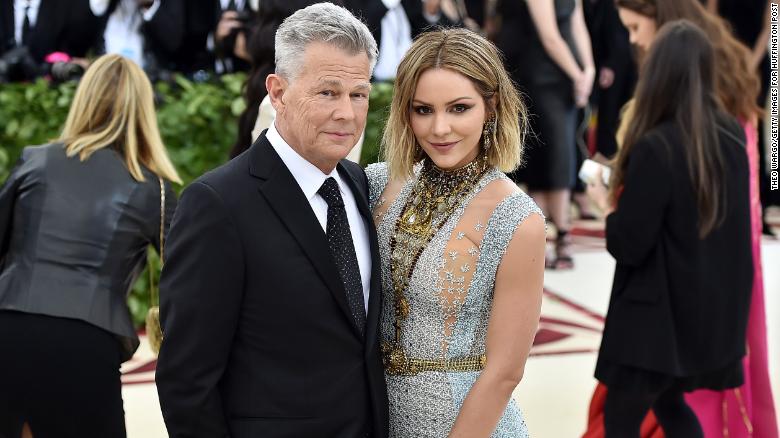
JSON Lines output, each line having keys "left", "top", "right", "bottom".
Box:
{"left": 265, "top": 123, "right": 371, "bottom": 313}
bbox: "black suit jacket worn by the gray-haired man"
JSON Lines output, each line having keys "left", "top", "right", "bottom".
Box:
{"left": 157, "top": 135, "right": 387, "bottom": 438}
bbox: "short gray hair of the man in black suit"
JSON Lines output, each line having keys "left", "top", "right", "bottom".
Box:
{"left": 274, "top": 3, "right": 378, "bottom": 80}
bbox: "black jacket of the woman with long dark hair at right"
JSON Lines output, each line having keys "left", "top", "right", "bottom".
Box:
{"left": 596, "top": 117, "right": 753, "bottom": 377}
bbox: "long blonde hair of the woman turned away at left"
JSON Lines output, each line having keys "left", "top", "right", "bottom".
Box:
{"left": 59, "top": 55, "right": 181, "bottom": 184}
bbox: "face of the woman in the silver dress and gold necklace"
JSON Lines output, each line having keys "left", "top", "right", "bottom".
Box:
{"left": 411, "top": 68, "right": 486, "bottom": 170}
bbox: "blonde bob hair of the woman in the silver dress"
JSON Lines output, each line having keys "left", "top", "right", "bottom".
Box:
{"left": 382, "top": 29, "right": 528, "bottom": 179}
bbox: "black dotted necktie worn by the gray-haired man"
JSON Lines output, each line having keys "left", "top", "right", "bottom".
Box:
{"left": 317, "top": 177, "right": 366, "bottom": 334}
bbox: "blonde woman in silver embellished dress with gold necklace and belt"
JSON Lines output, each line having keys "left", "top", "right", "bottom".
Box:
{"left": 366, "top": 29, "right": 545, "bottom": 438}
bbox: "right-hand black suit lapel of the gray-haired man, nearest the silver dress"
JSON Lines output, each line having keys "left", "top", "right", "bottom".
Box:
{"left": 338, "top": 163, "right": 382, "bottom": 352}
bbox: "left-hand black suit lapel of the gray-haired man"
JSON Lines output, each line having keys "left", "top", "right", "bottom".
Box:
{"left": 248, "top": 134, "right": 358, "bottom": 334}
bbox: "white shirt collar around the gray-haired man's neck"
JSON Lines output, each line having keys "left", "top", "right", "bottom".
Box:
{"left": 265, "top": 123, "right": 344, "bottom": 201}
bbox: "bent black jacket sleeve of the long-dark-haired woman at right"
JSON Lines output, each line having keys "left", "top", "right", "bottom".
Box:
{"left": 606, "top": 135, "right": 672, "bottom": 266}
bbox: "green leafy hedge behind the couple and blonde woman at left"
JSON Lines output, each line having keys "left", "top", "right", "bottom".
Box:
{"left": 0, "top": 74, "right": 393, "bottom": 326}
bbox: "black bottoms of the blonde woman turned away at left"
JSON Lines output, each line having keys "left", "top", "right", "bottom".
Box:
{"left": 0, "top": 311, "right": 126, "bottom": 438}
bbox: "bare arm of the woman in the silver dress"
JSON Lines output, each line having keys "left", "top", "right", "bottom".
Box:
{"left": 449, "top": 214, "right": 545, "bottom": 438}
